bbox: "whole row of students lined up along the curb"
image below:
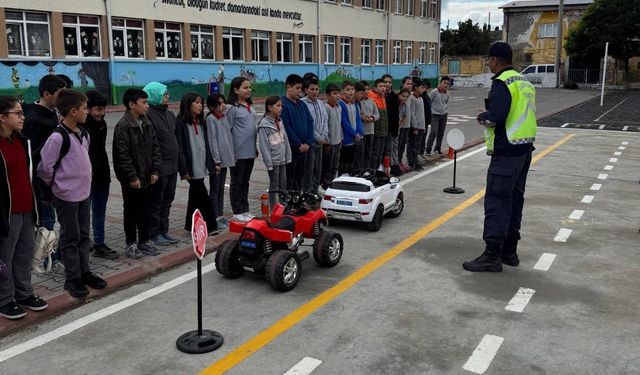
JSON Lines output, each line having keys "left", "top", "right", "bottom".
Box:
{"left": 0, "top": 73, "right": 449, "bottom": 319}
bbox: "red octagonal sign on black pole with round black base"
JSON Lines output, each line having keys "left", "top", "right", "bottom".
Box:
{"left": 176, "top": 210, "right": 224, "bottom": 354}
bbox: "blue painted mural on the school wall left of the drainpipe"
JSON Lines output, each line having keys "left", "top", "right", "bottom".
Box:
{"left": 0, "top": 61, "right": 110, "bottom": 103}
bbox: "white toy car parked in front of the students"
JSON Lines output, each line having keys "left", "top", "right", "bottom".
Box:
{"left": 321, "top": 169, "right": 404, "bottom": 232}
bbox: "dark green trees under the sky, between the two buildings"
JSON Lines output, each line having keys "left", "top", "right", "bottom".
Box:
{"left": 440, "top": 19, "right": 492, "bottom": 56}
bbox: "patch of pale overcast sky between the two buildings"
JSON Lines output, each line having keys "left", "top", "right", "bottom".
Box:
{"left": 442, "top": 0, "right": 504, "bottom": 29}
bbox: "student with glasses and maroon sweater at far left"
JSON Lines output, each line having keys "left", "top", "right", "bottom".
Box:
{"left": 0, "top": 96, "right": 47, "bottom": 319}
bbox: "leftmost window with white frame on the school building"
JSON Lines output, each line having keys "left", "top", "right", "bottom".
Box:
{"left": 5, "top": 10, "right": 51, "bottom": 57}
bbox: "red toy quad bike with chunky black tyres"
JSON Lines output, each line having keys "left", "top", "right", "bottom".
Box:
{"left": 215, "top": 192, "right": 343, "bottom": 291}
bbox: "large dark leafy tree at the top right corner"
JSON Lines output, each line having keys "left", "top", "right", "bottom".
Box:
{"left": 566, "top": 0, "right": 640, "bottom": 74}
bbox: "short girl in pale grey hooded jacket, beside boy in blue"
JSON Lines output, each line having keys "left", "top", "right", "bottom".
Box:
{"left": 258, "top": 96, "right": 291, "bottom": 209}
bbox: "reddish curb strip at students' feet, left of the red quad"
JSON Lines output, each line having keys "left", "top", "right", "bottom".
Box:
{"left": 0, "top": 232, "right": 237, "bottom": 338}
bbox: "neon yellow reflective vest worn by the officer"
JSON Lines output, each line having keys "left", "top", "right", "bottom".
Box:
{"left": 484, "top": 69, "right": 538, "bottom": 154}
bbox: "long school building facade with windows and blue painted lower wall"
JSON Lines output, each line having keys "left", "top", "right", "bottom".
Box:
{"left": 0, "top": 0, "right": 441, "bottom": 102}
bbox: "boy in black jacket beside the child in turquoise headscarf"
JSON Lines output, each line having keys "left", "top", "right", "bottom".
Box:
{"left": 111, "top": 89, "right": 162, "bottom": 259}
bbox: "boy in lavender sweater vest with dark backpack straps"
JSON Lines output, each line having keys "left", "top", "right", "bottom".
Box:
{"left": 38, "top": 89, "right": 107, "bottom": 298}
